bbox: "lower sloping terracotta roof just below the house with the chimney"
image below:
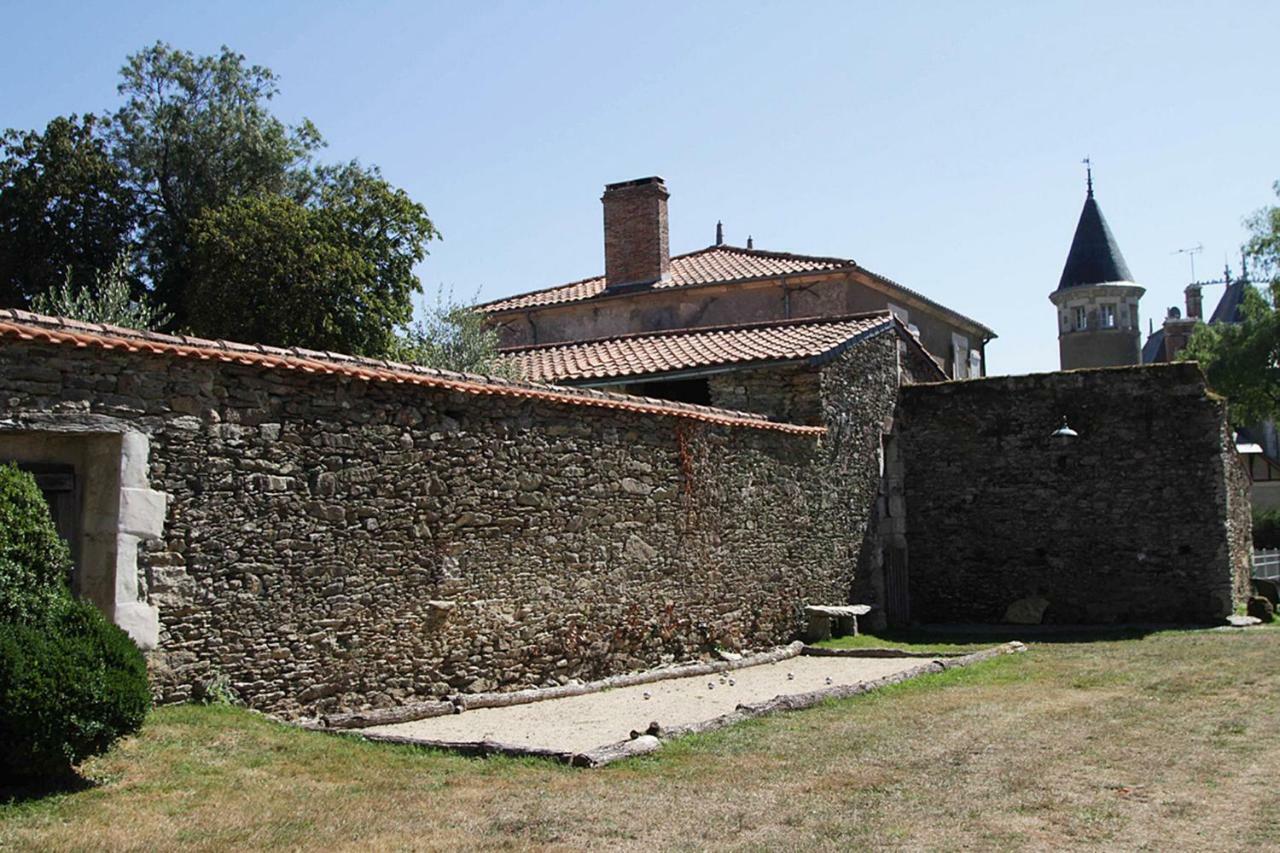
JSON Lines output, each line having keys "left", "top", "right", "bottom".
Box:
{"left": 504, "top": 311, "right": 909, "bottom": 382}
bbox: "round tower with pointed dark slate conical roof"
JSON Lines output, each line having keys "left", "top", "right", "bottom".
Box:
{"left": 1048, "top": 169, "right": 1146, "bottom": 370}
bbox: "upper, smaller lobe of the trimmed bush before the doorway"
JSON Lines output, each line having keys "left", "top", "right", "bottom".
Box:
{"left": 0, "top": 465, "right": 72, "bottom": 621}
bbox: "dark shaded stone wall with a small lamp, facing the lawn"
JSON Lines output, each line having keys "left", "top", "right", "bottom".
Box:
{"left": 901, "top": 364, "right": 1251, "bottom": 622}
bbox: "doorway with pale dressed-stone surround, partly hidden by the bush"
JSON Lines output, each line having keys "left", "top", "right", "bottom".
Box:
{"left": 0, "top": 429, "right": 165, "bottom": 648}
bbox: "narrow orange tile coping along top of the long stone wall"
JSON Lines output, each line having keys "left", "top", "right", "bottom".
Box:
{"left": 0, "top": 309, "right": 827, "bottom": 435}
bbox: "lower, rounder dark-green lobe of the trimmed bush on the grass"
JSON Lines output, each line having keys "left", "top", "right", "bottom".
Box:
{"left": 0, "top": 597, "right": 151, "bottom": 779}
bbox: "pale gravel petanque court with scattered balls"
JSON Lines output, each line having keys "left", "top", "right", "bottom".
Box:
{"left": 360, "top": 656, "right": 928, "bottom": 753}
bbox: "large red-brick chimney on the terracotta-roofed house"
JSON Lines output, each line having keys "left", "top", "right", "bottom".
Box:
{"left": 600, "top": 177, "right": 671, "bottom": 291}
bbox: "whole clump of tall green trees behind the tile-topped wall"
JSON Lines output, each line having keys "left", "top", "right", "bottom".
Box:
{"left": 0, "top": 42, "right": 439, "bottom": 356}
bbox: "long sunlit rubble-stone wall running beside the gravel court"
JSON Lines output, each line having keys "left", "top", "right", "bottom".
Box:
{"left": 0, "top": 320, "right": 897, "bottom": 715}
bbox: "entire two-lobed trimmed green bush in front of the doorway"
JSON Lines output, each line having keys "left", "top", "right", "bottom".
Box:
{"left": 0, "top": 465, "right": 151, "bottom": 779}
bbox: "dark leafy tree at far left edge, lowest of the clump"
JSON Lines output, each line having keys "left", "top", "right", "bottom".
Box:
{"left": 0, "top": 115, "right": 137, "bottom": 307}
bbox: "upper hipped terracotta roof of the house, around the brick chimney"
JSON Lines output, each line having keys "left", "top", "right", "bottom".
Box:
{"left": 476, "top": 246, "right": 996, "bottom": 337}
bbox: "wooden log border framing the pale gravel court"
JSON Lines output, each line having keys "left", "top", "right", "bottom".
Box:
{"left": 328, "top": 640, "right": 1027, "bottom": 767}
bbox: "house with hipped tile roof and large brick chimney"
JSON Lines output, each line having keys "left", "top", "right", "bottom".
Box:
{"left": 480, "top": 177, "right": 996, "bottom": 378}
